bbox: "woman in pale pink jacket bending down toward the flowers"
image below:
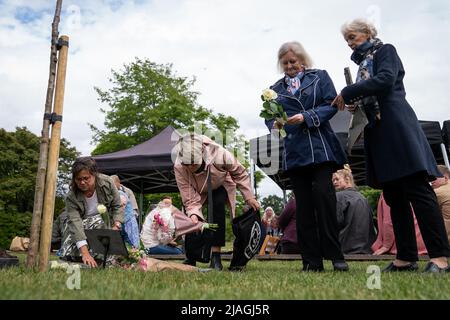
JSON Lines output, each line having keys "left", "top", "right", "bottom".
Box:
{"left": 174, "top": 134, "right": 260, "bottom": 270}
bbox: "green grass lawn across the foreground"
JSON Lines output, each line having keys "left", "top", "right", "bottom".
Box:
{"left": 0, "top": 252, "right": 450, "bottom": 300}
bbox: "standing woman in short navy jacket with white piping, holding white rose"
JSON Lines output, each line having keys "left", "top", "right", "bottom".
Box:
{"left": 266, "top": 42, "right": 348, "bottom": 271}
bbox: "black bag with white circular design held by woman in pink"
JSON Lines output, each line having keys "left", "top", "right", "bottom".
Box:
{"left": 228, "top": 208, "right": 262, "bottom": 271}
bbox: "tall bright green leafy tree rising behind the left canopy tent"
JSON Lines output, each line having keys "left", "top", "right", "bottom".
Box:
{"left": 90, "top": 58, "right": 242, "bottom": 155}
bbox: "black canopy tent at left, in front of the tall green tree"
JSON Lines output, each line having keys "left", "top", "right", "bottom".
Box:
{"left": 93, "top": 126, "right": 180, "bottom": 224}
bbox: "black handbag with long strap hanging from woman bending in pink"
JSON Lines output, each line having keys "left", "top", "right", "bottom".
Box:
{"left": 184, "top": 168, "right": 214, "bottom": 263}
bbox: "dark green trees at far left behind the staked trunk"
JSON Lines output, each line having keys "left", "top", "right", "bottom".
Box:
{"left": 0, "top": 127, "right": 79, "bottom": 212}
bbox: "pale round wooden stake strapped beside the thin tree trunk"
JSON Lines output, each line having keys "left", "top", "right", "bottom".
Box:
{"left": 39, "top": 36, "right": 69, "bottom": 272}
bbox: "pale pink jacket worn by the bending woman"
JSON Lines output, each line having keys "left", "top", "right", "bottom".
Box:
{"left": 174, "top": 136, "right": 255, "bottom": 220}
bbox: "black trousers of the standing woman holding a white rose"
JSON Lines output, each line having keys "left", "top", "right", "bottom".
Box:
{"left": 288, "top": 163, "right": 344, "bottom": 266}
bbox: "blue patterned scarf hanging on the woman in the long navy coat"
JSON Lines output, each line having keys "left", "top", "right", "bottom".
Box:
{"left": 351, "top": 38, "right": 383, "bottom": 128}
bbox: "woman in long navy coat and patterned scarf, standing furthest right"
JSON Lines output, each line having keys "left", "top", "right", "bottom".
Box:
{"left": 333, "top": 19, "right": 450, "bottom": 272}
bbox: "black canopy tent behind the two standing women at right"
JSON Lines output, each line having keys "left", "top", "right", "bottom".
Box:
{"left": 250, "top": 111, "right": 450, "bottom": 190}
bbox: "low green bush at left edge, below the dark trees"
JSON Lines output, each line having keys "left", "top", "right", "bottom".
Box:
{"left": 0, "top": 212, "right": 33, "bottom": 249}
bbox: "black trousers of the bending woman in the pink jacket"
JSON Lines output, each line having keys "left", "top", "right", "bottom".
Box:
{"left": 204, "top": 186, "right": 228, "bottom": 247}
